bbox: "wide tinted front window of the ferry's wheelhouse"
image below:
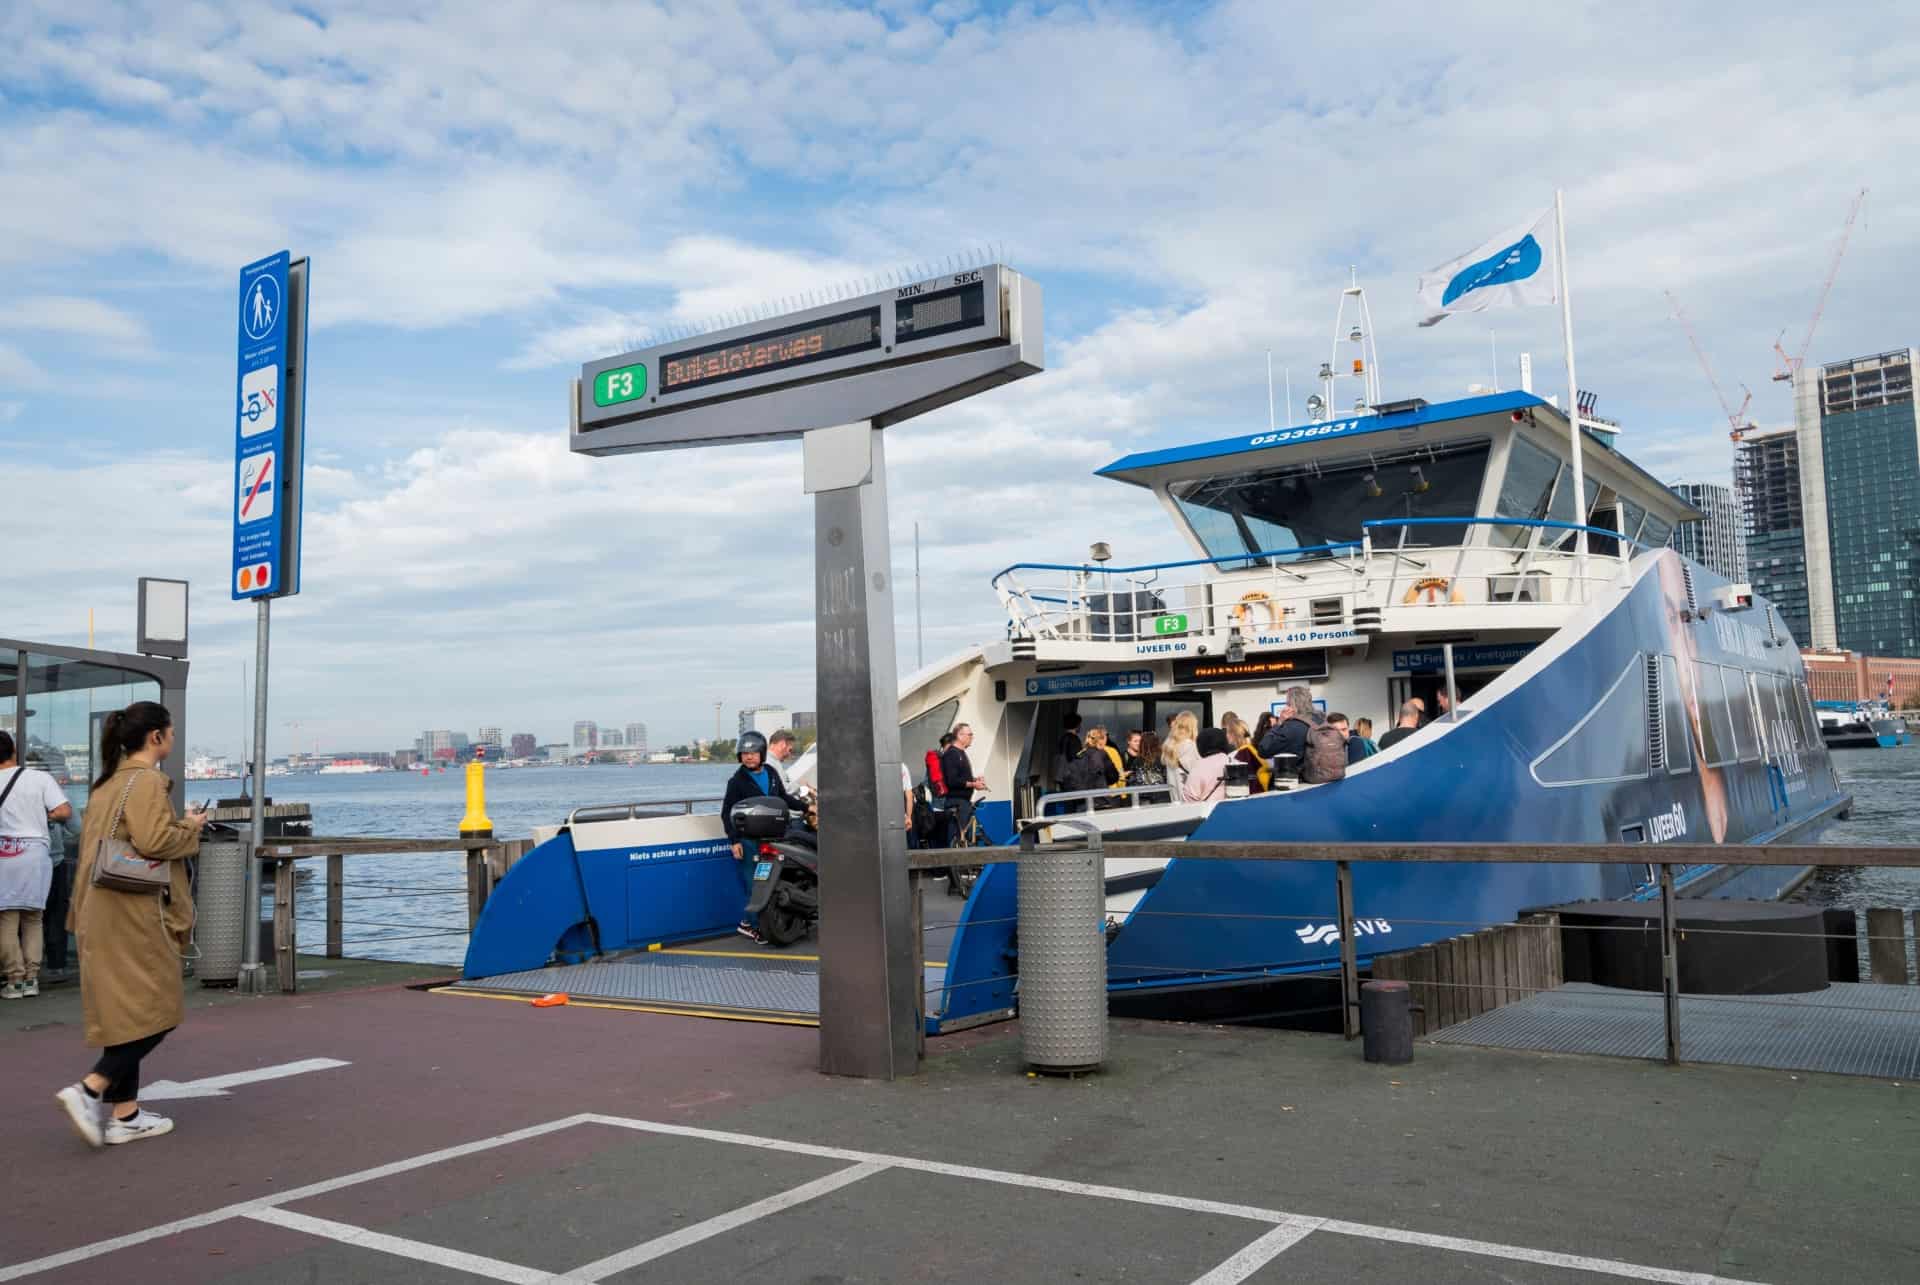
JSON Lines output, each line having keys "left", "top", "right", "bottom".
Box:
{"left": 1169, "top": 438, "right": 1490, "bottom": 570}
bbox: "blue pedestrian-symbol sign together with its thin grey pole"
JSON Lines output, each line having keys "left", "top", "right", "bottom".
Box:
{"left": 228, "top": 250, "right": 311, "bottom": 993}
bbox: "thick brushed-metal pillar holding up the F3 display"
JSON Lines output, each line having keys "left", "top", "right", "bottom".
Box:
{"left": 803, "top": 421, "right": 920, "bottom": 1079}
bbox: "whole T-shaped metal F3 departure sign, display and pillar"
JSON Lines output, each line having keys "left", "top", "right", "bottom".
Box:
{"left": 568, "top": 263, "right": 1043, "bottom": 1079}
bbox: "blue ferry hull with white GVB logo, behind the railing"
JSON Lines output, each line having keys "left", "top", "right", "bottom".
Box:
{"left": 921, "top": 549, "right": 1849, "bottom": 1024}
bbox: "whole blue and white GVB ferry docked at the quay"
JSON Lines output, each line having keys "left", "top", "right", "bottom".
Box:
{"left": 456, "top": 305, "right": 1851, "bottom": 1033}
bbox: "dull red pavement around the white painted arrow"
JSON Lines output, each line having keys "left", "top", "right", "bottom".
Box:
{"left": 0, "top": 987, "right": 818, "bottom": 1279}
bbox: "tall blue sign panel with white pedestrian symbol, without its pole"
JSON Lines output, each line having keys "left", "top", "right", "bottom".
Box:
{"left": 230, "top": 250, "right": 300, "bottom": 599}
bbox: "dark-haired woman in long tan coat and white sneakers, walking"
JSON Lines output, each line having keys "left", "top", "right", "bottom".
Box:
{"left": 56, "top": 701, "right": 207, "bottom": 1147}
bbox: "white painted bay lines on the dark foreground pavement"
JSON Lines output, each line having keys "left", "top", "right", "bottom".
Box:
{"left": 0, "top": 1114, "right": 1755, "bottom": 1285}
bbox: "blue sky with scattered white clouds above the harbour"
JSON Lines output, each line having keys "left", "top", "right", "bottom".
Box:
{"left": 0, "top": 0, "right": 1920, "bottom": 753}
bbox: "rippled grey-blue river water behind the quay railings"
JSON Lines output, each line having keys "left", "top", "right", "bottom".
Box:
{"left": 206, "top": 745, "right": 1920, "bottom": 964}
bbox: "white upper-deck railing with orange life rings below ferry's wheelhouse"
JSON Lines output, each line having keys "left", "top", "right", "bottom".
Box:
{"left": 993, "top": 517, "right": 1645, "bottom": 642}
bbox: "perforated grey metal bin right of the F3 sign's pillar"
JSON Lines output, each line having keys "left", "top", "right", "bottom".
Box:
{"left": 1018, "top": 818, "right": 1106, "bottom": 1074}
